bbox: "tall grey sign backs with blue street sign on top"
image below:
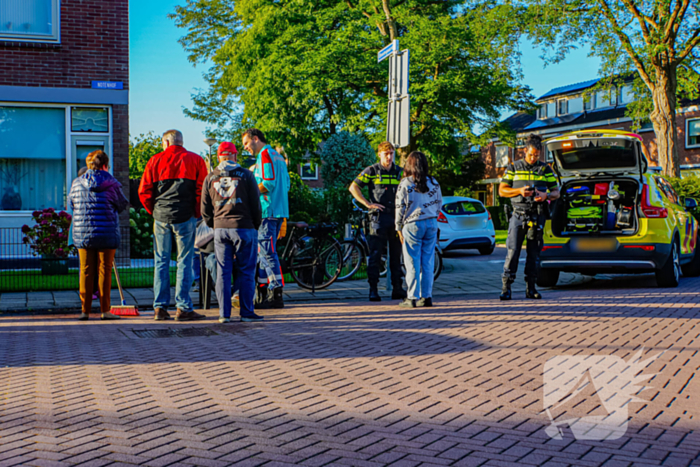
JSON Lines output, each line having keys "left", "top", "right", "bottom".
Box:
{"left": 377, "top": 39, "right": 411, "bottom": 148}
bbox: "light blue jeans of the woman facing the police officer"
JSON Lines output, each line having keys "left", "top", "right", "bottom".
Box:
{"left": 401, "top": 218, "right": 437, "bottom": 300}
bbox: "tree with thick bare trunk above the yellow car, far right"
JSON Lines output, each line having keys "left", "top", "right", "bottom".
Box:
{"left": 521, "top": 0, "right": 700, "bottom": 176}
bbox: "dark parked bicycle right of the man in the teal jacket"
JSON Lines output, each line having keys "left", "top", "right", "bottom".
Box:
{"left": 280, "top": 222, "right": 343, "bottom": 292}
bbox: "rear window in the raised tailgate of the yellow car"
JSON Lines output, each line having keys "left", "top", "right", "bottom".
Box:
{"left": 548, "top": 138, "right": 637, "bottom": 170}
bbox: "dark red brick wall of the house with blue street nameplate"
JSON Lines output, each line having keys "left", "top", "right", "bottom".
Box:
{"left": 0, "top": 0, "right": 129, "bottom": 260}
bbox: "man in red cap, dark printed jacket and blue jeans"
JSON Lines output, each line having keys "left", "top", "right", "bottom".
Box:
{"left": 202, "top": 142, "right": 263, "bottom": 323}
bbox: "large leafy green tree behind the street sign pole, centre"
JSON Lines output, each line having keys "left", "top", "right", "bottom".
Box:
{"left": 172, "top": 0, "right": 531, "bottom": 170}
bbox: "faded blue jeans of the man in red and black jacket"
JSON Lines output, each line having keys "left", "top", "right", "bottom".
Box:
{"left": 153, "top": 217, "right": 197, "bottom": 312}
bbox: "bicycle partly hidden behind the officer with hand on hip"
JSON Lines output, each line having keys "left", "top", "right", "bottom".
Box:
{"left": 338, "top": 199, "right": 443, "bottom": 280}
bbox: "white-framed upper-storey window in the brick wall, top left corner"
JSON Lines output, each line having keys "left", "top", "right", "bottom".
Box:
{"left": 0, "top": 0, "right": 59, "bottom": 42}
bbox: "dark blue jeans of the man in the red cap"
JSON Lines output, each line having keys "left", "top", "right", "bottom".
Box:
{"left": 214, "top": 229, "right": 258, "bottom": 318}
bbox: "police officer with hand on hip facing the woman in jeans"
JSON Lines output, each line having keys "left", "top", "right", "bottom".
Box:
{"left": 350, "top": 141, "right": 407, "bottom": 302}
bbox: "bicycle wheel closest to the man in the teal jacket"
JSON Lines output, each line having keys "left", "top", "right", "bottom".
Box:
{"left": 289, "top": 237, "right": 343, "bottom": 290}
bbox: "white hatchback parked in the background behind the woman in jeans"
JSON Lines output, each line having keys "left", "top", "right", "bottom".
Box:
{"left": 438, "top": 196, "right": 496, "bottom": 255}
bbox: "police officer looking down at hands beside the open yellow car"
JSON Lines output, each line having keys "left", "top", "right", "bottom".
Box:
{"left": 498, "top": 135, "right": 559, "bottom": 300}
